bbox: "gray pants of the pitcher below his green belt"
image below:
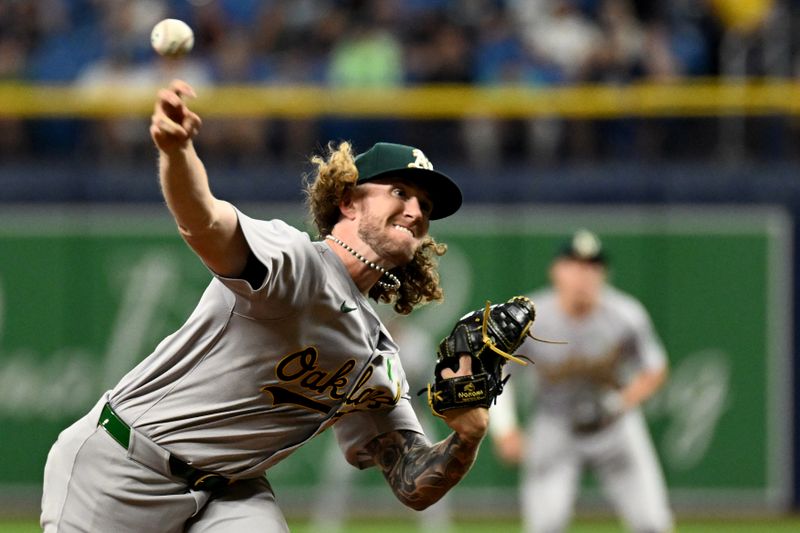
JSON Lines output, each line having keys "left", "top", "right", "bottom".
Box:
{"left": 41, "top": 394, "right": 289, "bottom": 533}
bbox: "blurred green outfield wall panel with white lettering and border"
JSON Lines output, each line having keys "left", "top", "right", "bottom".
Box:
{"left": 0, "top": 205, "right": 792, "bottom": 510}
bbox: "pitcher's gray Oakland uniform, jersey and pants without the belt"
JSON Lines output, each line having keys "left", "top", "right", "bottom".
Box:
{"left": 42, "top": 208, "right": 422, "bottom": 533}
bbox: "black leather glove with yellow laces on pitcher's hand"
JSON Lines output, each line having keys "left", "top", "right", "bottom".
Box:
{"left": 427, "top": 296, "right": 536, "bottom": 417}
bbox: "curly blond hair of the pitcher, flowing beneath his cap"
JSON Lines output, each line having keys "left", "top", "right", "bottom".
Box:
{"left": 304, "top": 141, "right": 447, "bottom": 315}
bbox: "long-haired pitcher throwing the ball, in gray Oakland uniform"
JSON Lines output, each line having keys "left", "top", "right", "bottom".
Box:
{"left": 41, "top": 80, "right": 533, "bottom": 533}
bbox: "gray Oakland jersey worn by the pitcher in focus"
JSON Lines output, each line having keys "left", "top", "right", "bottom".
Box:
{"left": 110, "top": 208, "right": 422, "bottom": 478}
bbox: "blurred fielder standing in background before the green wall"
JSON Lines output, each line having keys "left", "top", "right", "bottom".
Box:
{"left": 491, "top": 230, "right": 672, "bottom": 533}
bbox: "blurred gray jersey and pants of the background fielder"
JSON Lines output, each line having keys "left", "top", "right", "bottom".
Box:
{"left": 512, "top": 287, "right": 672, "bottom": 533}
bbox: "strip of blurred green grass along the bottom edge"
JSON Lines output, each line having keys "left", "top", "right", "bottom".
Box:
{"left": 9, "top": 517, "right": 800, "bottom": 533}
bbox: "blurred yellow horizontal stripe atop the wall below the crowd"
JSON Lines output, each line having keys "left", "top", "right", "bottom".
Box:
{"left": 0, "top": 80, "right": 800, "bottom": 119}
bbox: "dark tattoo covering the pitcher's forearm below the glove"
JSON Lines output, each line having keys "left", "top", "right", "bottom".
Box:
{"left": 367, "top": 431, "right": 478, "bottom": 510}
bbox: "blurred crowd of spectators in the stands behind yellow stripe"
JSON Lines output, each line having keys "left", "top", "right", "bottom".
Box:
{"left": 0, "top": 0, "right": 800, "bottom": 164}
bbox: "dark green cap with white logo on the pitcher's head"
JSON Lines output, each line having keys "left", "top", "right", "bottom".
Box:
{"left": 355, "top": 142, "right": 462, "bottom": 220}
